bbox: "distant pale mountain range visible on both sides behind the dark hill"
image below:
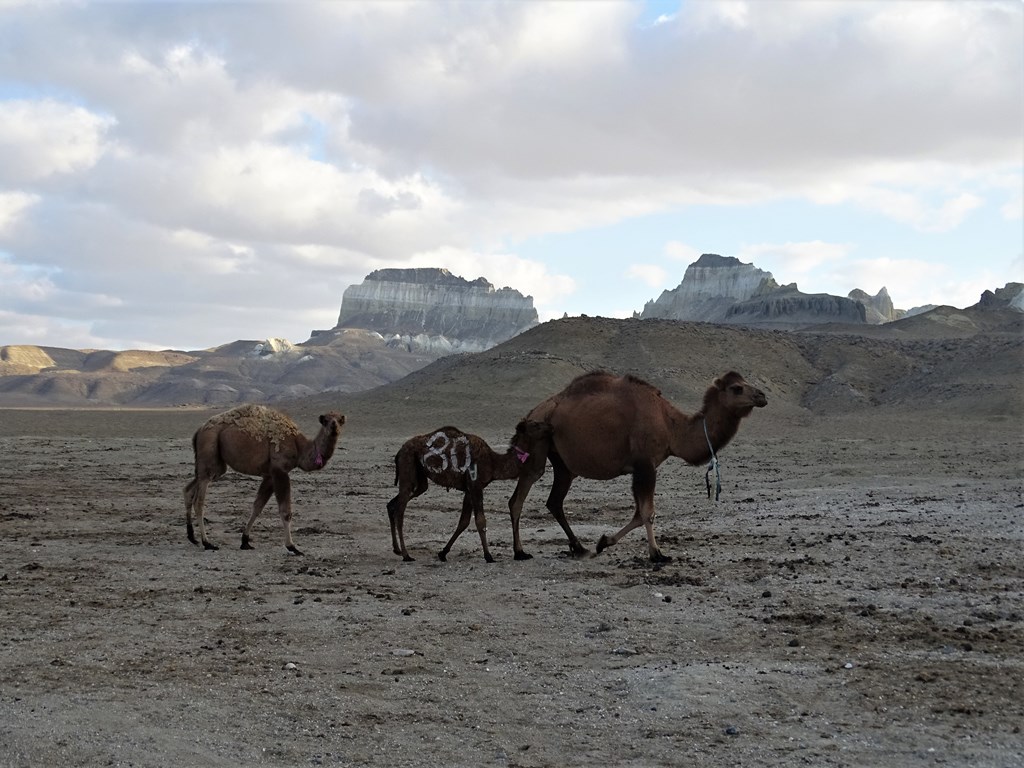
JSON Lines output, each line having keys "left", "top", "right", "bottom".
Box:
{"left": 0, "top": 260, "right": 1024, "bottom": 408}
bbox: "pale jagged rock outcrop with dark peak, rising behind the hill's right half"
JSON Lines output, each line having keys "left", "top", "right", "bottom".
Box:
{"left": 639, "top": 253, "right": 905, "bottom": 330}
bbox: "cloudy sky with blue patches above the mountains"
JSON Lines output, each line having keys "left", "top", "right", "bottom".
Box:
{"left": 0, "top": 0, "right": 1024, "bottom": 349}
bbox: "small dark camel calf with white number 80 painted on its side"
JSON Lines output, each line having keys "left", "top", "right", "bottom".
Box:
{"left": 387, "top": 421, "right": 551, "bottom": 562}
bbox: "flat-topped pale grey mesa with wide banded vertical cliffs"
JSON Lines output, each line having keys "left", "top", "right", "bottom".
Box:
{"left": 331, "top": 268, "right": 538, "bottom": 353}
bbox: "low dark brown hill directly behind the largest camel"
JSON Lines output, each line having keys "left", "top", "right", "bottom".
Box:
{"left": 301, "top": 307, "right": 1024, "bottom": 441}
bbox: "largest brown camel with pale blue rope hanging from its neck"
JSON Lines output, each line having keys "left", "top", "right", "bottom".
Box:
{"left": 509, "top": 371, "right": 768, "bottom": 562}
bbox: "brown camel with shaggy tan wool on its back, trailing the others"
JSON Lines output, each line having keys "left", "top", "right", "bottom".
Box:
{"left": 185, "top": 406, "right": 345, "bottom": 555}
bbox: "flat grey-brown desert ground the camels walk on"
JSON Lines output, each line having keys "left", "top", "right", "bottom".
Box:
{"left": 0, "top": 393, "right": 1024, "bottom": 768}
